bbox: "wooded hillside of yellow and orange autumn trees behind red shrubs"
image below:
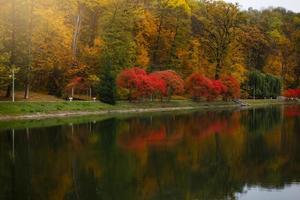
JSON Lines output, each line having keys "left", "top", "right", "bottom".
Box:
{"left": 0, "top": 0, "right": 300, "bottom": 98}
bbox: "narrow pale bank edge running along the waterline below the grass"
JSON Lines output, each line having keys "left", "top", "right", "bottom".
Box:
{"left": 0, "top": 100, "right": 299, "bottom": 121}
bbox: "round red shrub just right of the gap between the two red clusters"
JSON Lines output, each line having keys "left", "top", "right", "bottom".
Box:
{"left": 186, "top": 73, "right": 214, "bottom": 100}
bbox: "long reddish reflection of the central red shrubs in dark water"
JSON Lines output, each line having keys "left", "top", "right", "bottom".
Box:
{"left": 118, "top": 112, "right": 240, "bottom": 151}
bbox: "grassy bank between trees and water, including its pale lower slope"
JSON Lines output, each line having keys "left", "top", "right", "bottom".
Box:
{"left": 0, "top": 100, "right": 296, "bottom": 120}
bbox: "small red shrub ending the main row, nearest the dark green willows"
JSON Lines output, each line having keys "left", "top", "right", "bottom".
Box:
{"left": 221, "top": 76, "right": 241, "bottom": 100}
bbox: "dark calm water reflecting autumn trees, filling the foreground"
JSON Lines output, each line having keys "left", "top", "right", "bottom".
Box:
{"left": 0, "top": 106, "right": 300, "bottom": 200}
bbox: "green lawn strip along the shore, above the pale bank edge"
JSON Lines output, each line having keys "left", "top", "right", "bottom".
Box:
{"left": 0, "top": 100, "right": 234, "bottom": 115}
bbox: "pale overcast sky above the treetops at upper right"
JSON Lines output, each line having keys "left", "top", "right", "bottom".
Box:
{"left": 225, "top": 0, "right": 300, "bottom": 12}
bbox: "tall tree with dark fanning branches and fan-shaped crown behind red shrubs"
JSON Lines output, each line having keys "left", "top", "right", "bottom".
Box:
{"left": 193, "top": 1, "right": 239, "bottom": 80}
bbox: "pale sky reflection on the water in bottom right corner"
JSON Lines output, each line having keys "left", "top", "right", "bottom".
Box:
{"left": 236, "top": 184, "right": 300, "bottom": 200}
